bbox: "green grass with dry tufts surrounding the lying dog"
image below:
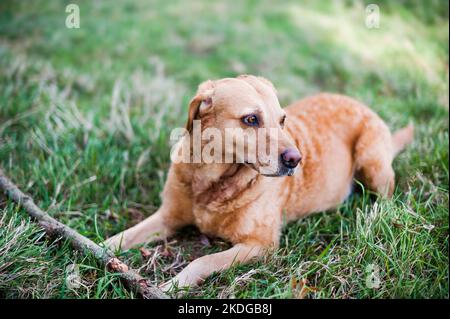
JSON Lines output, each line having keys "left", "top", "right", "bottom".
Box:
{"left": 0, "top": 0, "right": 449, "bottom": 298}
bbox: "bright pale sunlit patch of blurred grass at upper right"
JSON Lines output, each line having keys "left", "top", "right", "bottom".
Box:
{"left": 286, "top": 1, "right": 448, "bottom": 84}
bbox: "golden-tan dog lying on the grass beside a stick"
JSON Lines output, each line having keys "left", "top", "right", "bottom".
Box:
{"left": 105, "top": 75, "right": 413, "bottom": 291}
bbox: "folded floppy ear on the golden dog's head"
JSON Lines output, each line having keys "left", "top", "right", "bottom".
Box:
{"left": 186, "top": 80, "right": 214, "bottom": 133}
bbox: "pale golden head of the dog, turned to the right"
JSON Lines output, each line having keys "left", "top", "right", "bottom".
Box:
{"left": 186, "top": 75, "right": 301, "bottom": 176}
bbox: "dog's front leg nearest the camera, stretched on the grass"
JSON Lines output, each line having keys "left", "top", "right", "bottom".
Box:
{"left": 161, "top": 244, "right": 265, "bottom": 291}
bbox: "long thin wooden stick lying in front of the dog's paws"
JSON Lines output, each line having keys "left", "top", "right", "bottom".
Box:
{"left": 0, "top": 169, "right": 168, "bottom": 299}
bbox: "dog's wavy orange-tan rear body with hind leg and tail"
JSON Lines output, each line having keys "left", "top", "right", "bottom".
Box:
{"left": 286, "top": 93, "right": 413, "bottom": 219}
